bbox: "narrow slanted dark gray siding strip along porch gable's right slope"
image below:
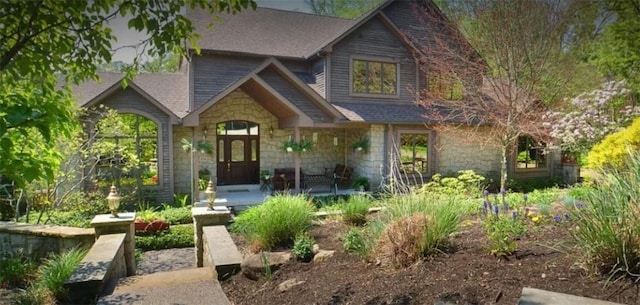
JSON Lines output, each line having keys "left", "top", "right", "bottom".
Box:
{"left": 258, "top": 68, "right": 331, "bottom": 123}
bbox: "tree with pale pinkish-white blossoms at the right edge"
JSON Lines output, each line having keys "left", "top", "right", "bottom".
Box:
{"left": 545, "top": 81, "right": 640, "bottom": 154}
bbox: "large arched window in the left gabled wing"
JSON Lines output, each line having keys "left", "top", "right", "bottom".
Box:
{"left": 92, "top": 112, "right": 159, "bottom": 187}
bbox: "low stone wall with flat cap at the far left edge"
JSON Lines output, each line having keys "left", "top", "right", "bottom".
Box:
{"left": 0, "top": 222, "right": 95, "bottom": 258}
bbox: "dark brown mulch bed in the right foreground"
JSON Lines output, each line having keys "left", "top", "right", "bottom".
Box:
{"left": 222, "top": 221, "right": 640, "bottom": 305}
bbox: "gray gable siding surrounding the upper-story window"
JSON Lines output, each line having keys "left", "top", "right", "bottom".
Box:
{"left": 329, "top": 18, "right": 416, "bottom": 103}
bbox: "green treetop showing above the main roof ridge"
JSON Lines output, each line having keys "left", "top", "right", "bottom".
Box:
{"left": 305, "top": 0, "right": 382, "bottom": 19}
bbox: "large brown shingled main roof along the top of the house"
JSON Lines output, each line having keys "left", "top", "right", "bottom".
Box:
{"left": 187, "top": 7, "right": 358, "bottom": 58}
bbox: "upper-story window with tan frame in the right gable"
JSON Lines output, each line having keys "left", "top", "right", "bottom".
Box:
{"left": 351, "top": 59, "right": 398, "bottom": 95}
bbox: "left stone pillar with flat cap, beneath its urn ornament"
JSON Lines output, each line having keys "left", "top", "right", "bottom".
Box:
{"left": 91, "top": 212, "right": 136, "bottom": 276}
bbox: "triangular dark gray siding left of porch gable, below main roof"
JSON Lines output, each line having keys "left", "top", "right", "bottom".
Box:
{"left": 191, "top": 54, "right": 264, "bottom": 109}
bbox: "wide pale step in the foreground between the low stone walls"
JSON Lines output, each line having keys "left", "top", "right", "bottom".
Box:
{"left": 97, "top": 268, "right": 231, "bottom": 305}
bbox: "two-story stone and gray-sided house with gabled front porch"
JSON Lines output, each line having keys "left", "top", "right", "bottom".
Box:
{"left": 77, "top": 0, "right": 559, "bottom": 201}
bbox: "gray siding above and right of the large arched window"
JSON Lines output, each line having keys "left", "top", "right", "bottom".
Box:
{"left": 102, "top": 88, "right": 173, "bottom": 202}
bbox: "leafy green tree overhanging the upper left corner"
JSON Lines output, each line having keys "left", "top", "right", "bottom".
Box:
{"left": 0, "top": 0, "right": 256, "bottom": 186}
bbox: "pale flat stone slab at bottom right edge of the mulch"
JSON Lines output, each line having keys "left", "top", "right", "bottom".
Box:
{"left": 518, "top": 287, "right": 622, "bottom": 305}
